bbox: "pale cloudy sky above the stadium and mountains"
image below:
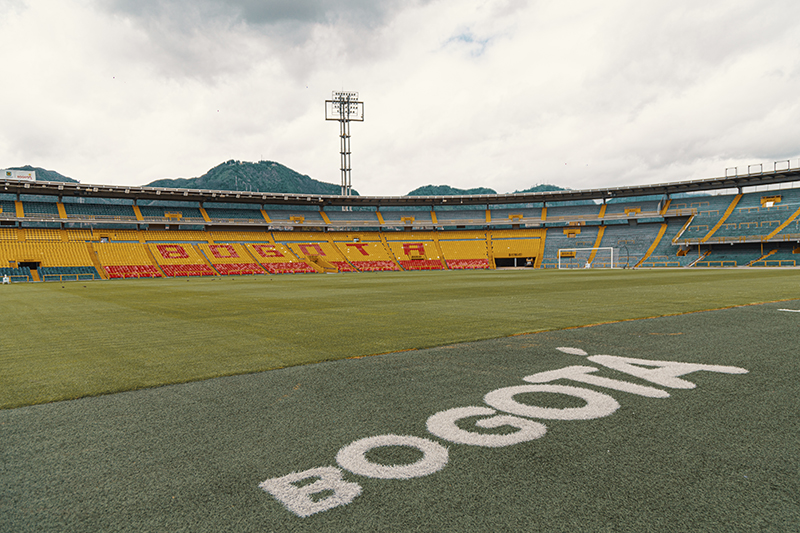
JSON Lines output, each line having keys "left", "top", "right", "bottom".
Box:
{"left": 0, "top": 0, "right": 800, "bottom": 195}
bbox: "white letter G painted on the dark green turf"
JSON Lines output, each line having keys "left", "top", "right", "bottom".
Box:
{"left": 427, "top": 406, "right": 547, "bottom": 448}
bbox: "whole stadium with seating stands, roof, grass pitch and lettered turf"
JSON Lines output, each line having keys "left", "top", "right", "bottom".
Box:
{"left": 0, "top": 161, "right": 800, "bottom": 532}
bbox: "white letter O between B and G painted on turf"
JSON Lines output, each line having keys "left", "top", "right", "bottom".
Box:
{"left": 336, "top": 435, "right": 448, "bottom": 479}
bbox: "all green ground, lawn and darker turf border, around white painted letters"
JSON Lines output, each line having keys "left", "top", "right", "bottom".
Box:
{"left": 0, "top": 269, "right": 800, "bottom": 532}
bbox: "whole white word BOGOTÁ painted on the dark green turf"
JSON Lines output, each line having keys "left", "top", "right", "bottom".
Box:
{"left": 259, "top": 348, "right": 747, "bottom": 518}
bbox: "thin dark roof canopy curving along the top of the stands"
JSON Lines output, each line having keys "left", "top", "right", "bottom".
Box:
{"left": 0, "top": 168, "right": 800, "bottom": 207}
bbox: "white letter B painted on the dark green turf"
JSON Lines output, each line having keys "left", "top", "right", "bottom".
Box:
{"left": 259, "top": 466, "right": 361, "bottom": 518}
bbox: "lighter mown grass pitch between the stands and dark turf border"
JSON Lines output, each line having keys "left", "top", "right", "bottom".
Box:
{"left": 0, "top": 269, "right": 800, "bottom": 408}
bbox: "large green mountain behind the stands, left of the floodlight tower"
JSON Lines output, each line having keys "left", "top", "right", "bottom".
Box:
{"left": 145, "top": 159, "right": 358, "bottom": 195}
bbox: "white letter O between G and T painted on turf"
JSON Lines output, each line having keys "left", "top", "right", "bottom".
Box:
{"left": 483, "top": 385, "right": 619, "bottom": 420}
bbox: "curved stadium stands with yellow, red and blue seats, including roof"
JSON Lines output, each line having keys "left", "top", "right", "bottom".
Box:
{"left": 0, "top": 164, "right": 800, "bottom": 281}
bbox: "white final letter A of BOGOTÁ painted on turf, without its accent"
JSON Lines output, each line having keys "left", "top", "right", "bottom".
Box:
{"left": 587, "top": 355, "right": 747, "bottom": 389}
